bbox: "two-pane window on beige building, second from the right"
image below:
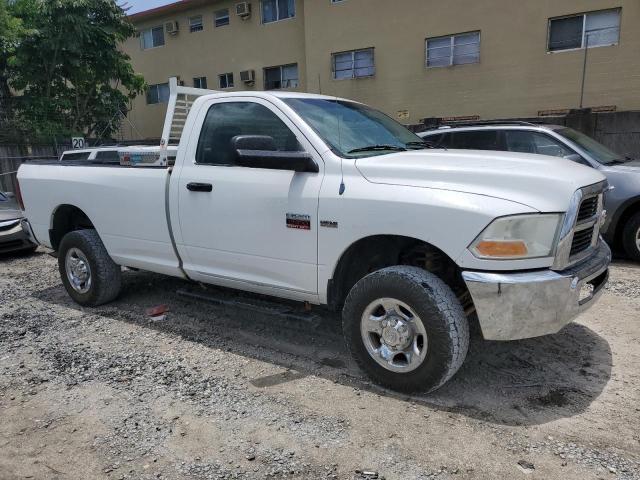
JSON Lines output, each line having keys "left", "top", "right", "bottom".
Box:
{"left": 427, "top": 32, "right": 480, "bottom": 67}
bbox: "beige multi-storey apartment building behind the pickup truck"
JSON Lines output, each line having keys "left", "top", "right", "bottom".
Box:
{"left": 123, "top": 0, "right": 640, "bottom": 138}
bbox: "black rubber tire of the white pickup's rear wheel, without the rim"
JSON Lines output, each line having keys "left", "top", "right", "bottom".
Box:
{"left": 58, "top": 230, "right": 122, "bottom": 307}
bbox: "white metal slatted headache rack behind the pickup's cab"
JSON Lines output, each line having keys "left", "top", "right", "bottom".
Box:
{"left": 160, "top": 77, "right": 221, "bottom": 161}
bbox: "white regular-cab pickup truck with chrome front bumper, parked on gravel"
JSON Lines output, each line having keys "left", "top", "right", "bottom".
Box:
{"left": 18, "top": 81, "right": 611, "bottom": 391}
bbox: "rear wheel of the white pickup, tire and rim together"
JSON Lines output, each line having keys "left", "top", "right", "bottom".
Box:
{"left": 58, "top": 230, "right": 122, "bottom": 307}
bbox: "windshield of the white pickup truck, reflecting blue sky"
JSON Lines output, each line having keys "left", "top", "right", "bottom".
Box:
{"left": 284, "top": 98, "right": 429, "bottom": 158}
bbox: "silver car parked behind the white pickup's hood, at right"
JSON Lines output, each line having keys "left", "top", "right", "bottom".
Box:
{"left": 418, "top": 122, "right": 640, "bottom": 261}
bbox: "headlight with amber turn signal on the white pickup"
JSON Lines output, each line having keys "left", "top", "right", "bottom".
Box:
{"left": 469, "top": 213, "right": 562, "bottom": 260}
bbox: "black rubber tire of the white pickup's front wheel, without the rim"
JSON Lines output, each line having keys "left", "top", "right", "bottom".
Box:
{"left": 342, "top": 266, "right": 469, "bottom": 392}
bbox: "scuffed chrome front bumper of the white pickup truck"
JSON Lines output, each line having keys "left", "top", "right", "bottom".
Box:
{"left": 462, "top": 240, "right": 611, "bottom": 340}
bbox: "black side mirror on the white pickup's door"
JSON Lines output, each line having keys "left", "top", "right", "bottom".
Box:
{"left": 231, "top": 135, "right": 320, "bottom": 173}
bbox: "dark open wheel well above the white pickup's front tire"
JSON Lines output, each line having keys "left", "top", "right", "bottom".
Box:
{"left": 327, "top": 234, "right": 473, "bottom": 310}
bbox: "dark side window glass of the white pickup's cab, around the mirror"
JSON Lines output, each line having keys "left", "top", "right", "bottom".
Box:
{"left": 196, "top": 102, "right": 301, "bottom": 165}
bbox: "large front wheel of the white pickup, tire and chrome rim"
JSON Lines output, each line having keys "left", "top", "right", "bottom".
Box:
{"left": 342, "top": 266, "right": 469, "bottom": 392}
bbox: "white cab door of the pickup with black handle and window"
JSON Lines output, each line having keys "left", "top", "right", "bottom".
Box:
{"left": 173, "top": 97, "right": 324, "bottom": 300}
